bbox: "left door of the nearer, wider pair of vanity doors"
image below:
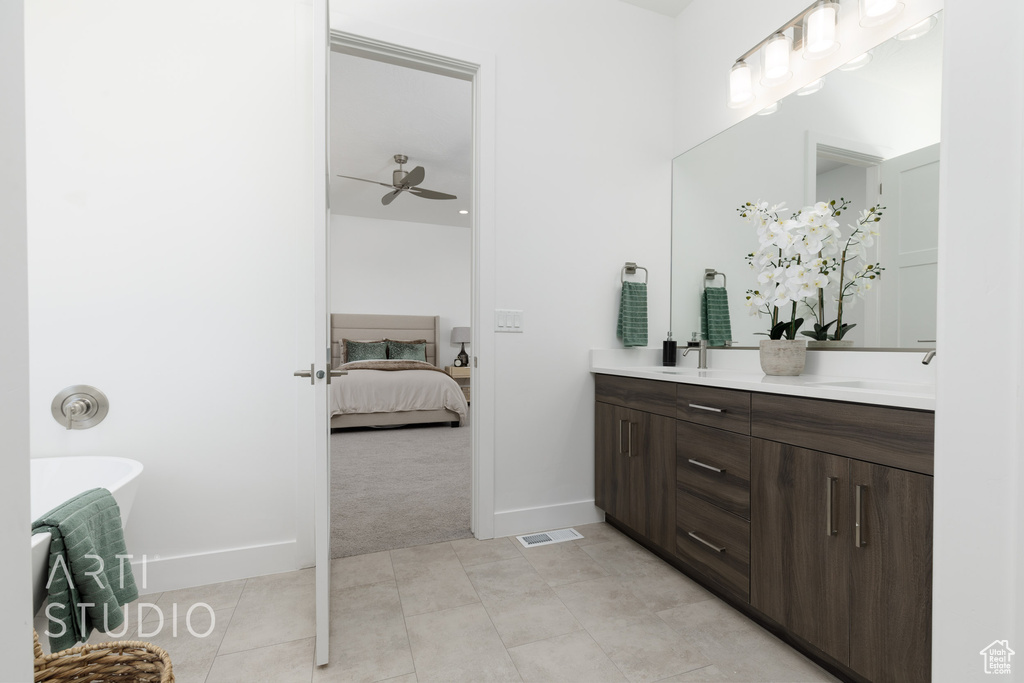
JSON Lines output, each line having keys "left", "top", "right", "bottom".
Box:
{"left": 751, "top": 439, "right": 853, "bottom": 664}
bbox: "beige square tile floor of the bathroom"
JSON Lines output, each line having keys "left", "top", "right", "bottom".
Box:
{"left": 37, "top": 524, "right": 836, "bottom": 683}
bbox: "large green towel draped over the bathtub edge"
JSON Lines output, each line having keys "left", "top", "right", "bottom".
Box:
{"left": 32, "top": 488, "right": 138, "bottom": 652}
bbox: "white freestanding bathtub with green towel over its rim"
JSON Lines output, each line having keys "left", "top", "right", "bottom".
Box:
{"left": 31, "top": 456, "right": 142, "bottom": 612}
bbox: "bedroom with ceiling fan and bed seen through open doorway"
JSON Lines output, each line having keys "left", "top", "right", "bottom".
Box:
{"left": 329, "top": 44, "right": 473, "bottom": 557}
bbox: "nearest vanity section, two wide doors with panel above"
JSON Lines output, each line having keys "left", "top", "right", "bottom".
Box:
{"left": 751, "top": 394, "right": 934, "bottom": 683}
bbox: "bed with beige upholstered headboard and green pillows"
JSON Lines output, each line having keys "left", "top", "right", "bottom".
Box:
{"left": 330, "top": 313, "right": 469, "bottom": 428}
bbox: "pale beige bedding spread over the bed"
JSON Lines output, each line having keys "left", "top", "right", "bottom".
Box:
{"left": 331, "top": 360, "right": 469, "bottom": 422}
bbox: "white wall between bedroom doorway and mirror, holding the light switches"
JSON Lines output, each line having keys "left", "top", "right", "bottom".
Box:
{"left": 332, "top": 0, "right": 673, "bottom": 536}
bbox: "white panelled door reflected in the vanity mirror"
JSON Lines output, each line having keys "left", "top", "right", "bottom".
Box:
{"left": 878, "top": 143, "right": 939, "bottom": 347}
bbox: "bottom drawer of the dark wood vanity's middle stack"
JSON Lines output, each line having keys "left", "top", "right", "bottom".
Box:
{"left": 676, "top": 490, "right": 751, "bottom": 600}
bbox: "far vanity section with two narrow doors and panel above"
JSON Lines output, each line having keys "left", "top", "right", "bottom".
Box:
{"left": 594, "top": 375, "right": 676, "bottom": 551}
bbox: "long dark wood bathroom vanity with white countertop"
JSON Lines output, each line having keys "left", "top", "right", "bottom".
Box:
{"left": 594, "top": 368, "right": 934, "bottom": 683}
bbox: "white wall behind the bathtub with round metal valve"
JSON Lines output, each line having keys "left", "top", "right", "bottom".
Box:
{"left": 26, "top": 0, "right": 313, "bottom": 592}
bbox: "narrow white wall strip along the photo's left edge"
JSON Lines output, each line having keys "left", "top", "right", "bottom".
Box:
{"left": 0, "top": 0, "right": 32, "bottom": 683}
